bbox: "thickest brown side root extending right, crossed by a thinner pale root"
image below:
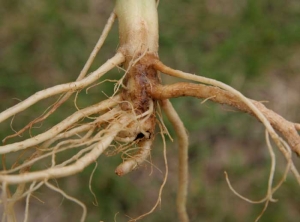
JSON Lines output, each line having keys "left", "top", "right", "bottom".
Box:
{"left": 150, "top": 82, "right": 300, "bottom": 155}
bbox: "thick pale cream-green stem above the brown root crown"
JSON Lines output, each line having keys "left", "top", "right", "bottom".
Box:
{"left": 115, "top": 0, "right": 158, "bottom": 57}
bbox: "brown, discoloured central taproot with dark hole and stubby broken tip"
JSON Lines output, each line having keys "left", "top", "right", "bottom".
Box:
{"left": 115, "top": 54, "right": 160, "bottom": 176}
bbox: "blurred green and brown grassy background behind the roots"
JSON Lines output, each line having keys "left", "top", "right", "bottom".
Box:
{"left": 0, "top": 0, "right": 300, "bottom": 222}
